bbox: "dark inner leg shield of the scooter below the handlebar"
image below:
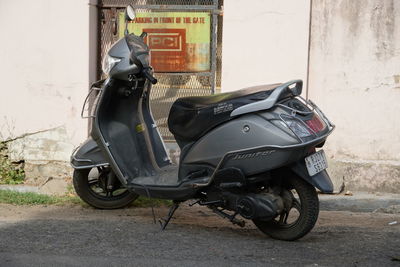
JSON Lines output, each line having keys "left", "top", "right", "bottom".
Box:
{"left": 91, "top": 80, "right": 155, "bottom": 184}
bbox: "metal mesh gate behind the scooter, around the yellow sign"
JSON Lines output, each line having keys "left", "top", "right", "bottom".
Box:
{"left": 98, "top": 0, "right": 223, "bottom": 141}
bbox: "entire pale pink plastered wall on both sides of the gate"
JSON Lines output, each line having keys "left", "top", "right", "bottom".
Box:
{"left": 0, "top": 0, "right": 400, "bottom": 195}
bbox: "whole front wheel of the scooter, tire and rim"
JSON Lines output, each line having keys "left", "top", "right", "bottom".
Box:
{"left": 73, "top": 167, "right": 138, "bottom": 209}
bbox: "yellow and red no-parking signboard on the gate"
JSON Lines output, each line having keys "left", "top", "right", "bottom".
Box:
{"left": 119, "top": 12, "right": 211, "bottom": 72}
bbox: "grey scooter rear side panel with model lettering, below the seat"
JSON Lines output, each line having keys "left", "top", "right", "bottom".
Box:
{"left": 183, "top": 114, "right": 298, "bottom": 175}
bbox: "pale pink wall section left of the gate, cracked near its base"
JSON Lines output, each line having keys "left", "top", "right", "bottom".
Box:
{"left": 0, "top": 0, "right": 96, "bottom": 193}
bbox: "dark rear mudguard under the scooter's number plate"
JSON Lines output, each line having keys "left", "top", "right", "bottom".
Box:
{"left": 290, "top": 161, "right": 333, "bottom": 194}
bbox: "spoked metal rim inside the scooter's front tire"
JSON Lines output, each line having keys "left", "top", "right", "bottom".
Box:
{"left": 88, "top": 167, "right": 129, "bottom": 200}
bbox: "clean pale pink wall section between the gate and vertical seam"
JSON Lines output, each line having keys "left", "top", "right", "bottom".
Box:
{"left": 221, "top": 0, "right": 310, "bottom": 92}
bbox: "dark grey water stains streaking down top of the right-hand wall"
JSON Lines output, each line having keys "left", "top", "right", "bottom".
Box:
{"left": 318, "top": 0, "right": 400, "bottom": 61}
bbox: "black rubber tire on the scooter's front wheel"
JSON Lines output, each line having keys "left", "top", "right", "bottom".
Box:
{"left": 73, "top": 169, "right": 138, "bottom": 209}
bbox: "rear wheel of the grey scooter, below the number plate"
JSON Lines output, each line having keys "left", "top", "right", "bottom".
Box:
{"left": 253, "top": 176, "right": 319, "bottom": 241}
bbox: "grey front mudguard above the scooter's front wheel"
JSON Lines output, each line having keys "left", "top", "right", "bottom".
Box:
{"left": 71, "top": 138, "right": 109, "bottom": 169}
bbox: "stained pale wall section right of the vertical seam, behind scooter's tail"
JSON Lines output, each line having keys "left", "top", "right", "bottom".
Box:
{"left": 309, "top": 0, "right": 400, "bottom": 192}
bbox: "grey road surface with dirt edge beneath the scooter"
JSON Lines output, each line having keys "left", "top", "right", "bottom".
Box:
{"left": 0, "top": 204, "right": 400, "bottom": 266}
